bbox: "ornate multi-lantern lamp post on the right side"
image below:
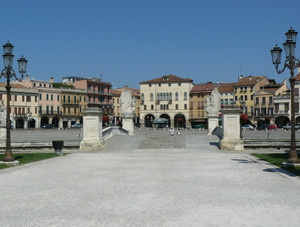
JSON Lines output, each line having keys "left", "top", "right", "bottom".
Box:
{"left": 271, "top": 27, "right": 299, "bottom": 164}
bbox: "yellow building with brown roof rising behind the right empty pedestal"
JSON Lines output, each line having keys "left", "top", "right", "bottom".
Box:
{"left": 233, "top": 76, "right": 269, "bottom": 120}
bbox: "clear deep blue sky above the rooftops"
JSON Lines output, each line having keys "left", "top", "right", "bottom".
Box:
{"left": 0, "top": 0, "right": 300, "bottom": 88}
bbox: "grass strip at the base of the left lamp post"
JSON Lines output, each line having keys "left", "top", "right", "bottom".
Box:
{"left": 0, "top": 153, "right": 60, "bottom": 169}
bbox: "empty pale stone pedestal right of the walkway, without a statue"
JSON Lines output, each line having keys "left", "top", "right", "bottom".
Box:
{"left": 220, "top": 106, "right": 244, "bottom": 151}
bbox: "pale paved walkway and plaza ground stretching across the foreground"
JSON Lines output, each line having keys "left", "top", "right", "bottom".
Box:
{"left": 0, "top": 129, "right": 300, "bottom": 226}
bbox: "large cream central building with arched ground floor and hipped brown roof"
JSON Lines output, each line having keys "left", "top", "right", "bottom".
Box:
{"left": 140, "top": 75, "right": 193, "bottom": 127}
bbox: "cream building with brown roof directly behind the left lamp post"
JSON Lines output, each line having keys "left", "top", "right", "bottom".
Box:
{"left": 0, "top": 83, "right": 39, "bottom": 129}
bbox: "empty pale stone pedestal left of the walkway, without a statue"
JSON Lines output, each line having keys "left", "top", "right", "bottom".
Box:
{"left": 80, "top": 107, "right": 105, "bottom": 151}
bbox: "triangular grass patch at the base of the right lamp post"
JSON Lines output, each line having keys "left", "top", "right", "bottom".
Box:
{"left": 252, "top": 153, "right": 300, "bottom": 176}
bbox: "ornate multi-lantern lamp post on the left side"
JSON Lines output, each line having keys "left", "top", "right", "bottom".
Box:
{"left": 0, "top": 42, "right": 27, "bottom": 162}
